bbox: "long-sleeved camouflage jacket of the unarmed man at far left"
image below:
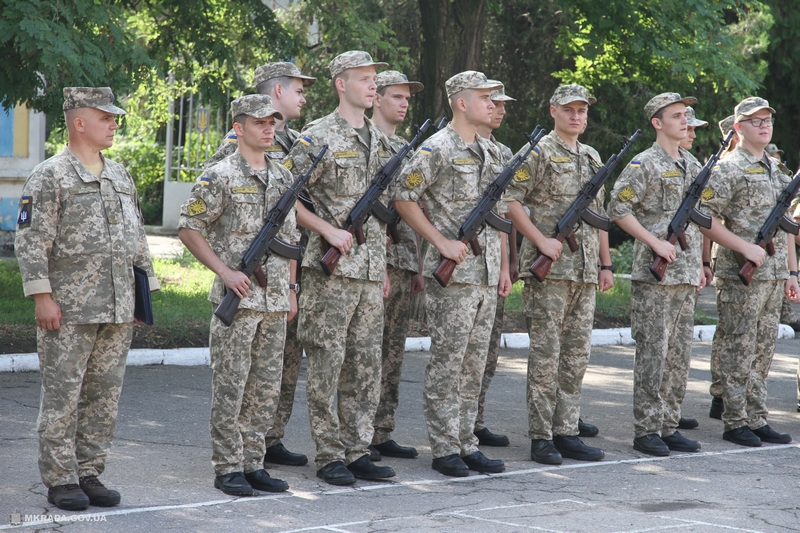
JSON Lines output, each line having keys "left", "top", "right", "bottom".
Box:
{"left": 14, "top": 147, "right": 159, "bottom": 324}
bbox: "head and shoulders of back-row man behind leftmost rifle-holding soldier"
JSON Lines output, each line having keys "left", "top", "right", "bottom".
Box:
{"left": 205, "top": 61, "right": 317, "bottom": 169}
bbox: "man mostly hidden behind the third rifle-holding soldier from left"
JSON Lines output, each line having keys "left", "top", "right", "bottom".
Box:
{"left": 474, "top": 80, "right": 519, "bottom": 446}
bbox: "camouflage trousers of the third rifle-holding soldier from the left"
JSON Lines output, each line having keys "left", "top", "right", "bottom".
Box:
{"left": 422, "top": 279, "right": 497, "bottom": 458}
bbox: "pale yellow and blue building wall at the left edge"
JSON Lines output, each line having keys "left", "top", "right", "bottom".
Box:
{"left": 0, "top": 104, "right": 45, "bottom": 247}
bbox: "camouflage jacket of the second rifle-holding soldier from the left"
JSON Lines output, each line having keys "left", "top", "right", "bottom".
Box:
{"left": 284, "top": 110, "right": 391, "bottom": 281}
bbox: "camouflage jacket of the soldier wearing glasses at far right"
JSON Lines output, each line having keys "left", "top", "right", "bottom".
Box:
{"left": 702, "top": 145, "right": 792, "bottom": 281}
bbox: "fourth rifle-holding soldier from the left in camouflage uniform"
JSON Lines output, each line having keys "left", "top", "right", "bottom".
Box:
{"left": 508, "top": 85, "right": 614, "bottom": 464}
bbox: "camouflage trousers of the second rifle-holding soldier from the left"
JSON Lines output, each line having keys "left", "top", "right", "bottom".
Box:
{"left": 297, "top": 268, "right": 383, "bottom": 469}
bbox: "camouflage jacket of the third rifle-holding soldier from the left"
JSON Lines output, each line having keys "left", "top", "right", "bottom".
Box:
{"left": 394, "top": 125, "right": 507, "bottom": 286}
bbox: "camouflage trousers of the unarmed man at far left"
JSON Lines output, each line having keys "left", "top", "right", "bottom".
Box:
{"left": 37, "top": 322, "right": 133, "bottom": 487}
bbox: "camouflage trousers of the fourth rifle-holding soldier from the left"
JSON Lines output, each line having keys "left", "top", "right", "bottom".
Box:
{"left": 522, "top": 279, "right": 597, "bottom": 440}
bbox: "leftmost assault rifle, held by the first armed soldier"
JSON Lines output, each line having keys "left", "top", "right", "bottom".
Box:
{"left": 214, "top": 144, "right": 328, "bottom": 326}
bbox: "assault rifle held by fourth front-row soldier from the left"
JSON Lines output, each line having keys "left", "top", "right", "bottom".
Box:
{"left": 528, "top": 130, "right": 642, "bottom": 283}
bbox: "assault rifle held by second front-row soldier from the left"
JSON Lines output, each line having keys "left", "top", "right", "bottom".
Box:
{"left": 319, "top": 119, "right": 431, "bottom": 276}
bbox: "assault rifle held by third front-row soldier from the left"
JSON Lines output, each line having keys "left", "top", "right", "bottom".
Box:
{"left": 433, "top": 124, "right": 546, "bottom": 287}
